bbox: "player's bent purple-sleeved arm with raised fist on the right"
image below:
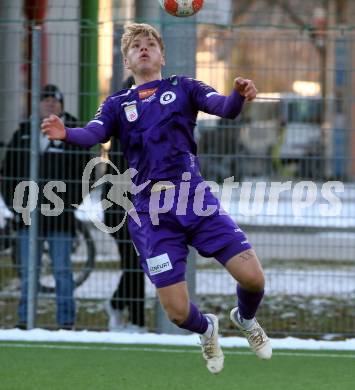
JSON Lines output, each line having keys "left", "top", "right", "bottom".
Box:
{"left": 192, "top": 77, "right": 257, "bottom": 119}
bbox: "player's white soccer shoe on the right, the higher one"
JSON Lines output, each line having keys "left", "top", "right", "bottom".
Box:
{"left": 230, "top": 307, "right": 272, "bottom": 359}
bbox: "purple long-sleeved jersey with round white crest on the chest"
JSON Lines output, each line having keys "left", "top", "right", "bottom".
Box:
{"left": 67, "top": 76, "right": 244, "bottom": 185}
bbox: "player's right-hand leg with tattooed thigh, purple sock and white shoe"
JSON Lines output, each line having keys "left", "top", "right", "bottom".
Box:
{"left": 226, "top": 249, "right": 272, "bottom": 359}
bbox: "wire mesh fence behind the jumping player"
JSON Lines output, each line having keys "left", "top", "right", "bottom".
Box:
{"left": 0, "top": 0, "right": 355, "bottom": 337}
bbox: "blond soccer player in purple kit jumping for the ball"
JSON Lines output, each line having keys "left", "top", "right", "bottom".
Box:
{"left": 42, "top": 24, "right": 272, "bottom": 374}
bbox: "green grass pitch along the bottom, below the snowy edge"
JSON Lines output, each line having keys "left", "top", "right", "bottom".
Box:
{"left": 0, "top": 342, "right": 355, "bottom": 390}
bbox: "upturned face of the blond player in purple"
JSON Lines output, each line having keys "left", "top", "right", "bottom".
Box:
{"left": 124, "top": 35, "right": 165, "bottom": 75}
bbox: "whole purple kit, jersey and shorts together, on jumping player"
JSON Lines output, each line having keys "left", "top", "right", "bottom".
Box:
{"left": 67, "top": 76, "right": 251, "bottom": 287}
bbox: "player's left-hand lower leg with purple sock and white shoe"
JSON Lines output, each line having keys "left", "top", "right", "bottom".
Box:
{"left": 157, "top": 282, "right": 224, "bottom": 374}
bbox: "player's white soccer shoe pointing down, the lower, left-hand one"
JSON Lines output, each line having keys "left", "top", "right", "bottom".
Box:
{"left": 200, "top": 314, "right": 224, "bottom": 374}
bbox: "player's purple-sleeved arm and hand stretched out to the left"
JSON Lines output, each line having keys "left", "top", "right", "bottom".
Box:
{"left": 41, "top": 99, "right": 117, "bottom": 148}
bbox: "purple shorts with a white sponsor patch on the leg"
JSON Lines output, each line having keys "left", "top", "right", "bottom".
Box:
{"left": 128, "top": 182, "right": 251, "bottom": 288}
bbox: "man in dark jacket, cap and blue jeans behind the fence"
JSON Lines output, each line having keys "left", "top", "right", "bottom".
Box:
{"left": 1, "top": 84, "right": 88, "bottom": 328}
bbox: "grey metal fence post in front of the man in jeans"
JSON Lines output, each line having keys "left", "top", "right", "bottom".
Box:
{"left": 27, "top": 26, "right": 41, "bottom": 329}
